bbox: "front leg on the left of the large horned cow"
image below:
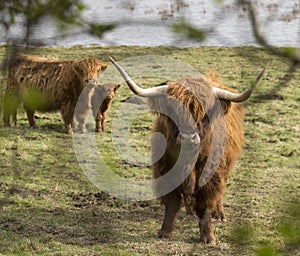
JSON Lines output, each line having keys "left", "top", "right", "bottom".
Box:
{"left": 158, "top": 190, "right": 181, "bottom": 238}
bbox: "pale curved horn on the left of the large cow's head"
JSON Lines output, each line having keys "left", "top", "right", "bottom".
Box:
{"left": 109, "top": 57, "right": 168, "bottom": 97}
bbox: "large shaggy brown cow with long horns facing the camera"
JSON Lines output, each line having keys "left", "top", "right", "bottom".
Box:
{"left": 111, "top": 59, "right": 266, "bottom": 243}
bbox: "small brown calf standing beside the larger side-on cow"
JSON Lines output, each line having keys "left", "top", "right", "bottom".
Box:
{"left": 74, "top": 83, "right": 120, "bottom": 133}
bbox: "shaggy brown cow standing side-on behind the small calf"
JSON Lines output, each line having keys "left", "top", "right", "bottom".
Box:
{"left": 3, "top": 54, "right": 107, "bottom": 133}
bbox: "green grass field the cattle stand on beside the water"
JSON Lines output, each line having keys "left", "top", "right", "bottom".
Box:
{"left": 0, "top": 46, "right": 300, "bottom": 256}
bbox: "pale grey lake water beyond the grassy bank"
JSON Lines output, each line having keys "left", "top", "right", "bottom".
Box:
{"left": 0, "top": 0, "right": 300, "bottom": 47}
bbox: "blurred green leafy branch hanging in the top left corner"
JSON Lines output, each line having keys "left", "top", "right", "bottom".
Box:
{"left": 0, "top": 0, "right": 115, "bottom": 46}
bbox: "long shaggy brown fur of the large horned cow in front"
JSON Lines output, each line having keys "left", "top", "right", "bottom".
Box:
{"left": 149, "top": 72, "right": 244, "bottom": 243}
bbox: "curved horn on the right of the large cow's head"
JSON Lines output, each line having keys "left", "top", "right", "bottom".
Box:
{"left": 213, "top": 64, "right": 268, "bottom": 102}
